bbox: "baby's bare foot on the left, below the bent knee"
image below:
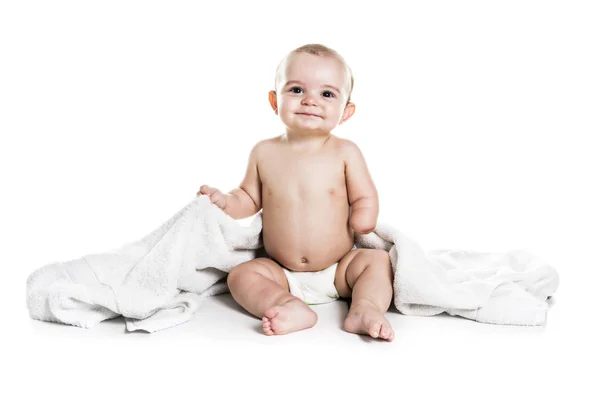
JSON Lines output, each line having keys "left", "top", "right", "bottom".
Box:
{"left": 263, "top": 298, "right": 317, "bottom": 336}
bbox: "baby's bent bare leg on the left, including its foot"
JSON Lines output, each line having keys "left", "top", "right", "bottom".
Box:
{"left": 227, "top": 258, "right": 317, "bottom": 335}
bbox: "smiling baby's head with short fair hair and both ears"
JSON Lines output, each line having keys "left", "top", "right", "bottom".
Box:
{"left": 269, "top": 44, "right": 355, "bottom": 134}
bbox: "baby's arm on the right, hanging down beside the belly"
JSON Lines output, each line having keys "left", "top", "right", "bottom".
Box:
{"left": 344, "top": 141, "right": 379, "bottom": 234}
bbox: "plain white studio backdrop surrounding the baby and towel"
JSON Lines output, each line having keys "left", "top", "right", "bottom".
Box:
{"left": 0, "top": 0, "right": 600, "bottom": 411}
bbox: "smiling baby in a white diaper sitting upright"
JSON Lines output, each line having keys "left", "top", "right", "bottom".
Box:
{"left": 197, "top": 44, "right": 394, "bottom": 341}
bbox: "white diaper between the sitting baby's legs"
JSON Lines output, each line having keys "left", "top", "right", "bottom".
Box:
{"left": 282, "top": 262, "right": 340, "bottom": 305}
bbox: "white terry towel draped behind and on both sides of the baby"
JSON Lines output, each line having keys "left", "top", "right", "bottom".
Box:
{"left": 27, "top": 195, "right": 558, "bottom": 332}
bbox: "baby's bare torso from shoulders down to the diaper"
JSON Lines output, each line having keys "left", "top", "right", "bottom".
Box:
{"left": 258, "top": 136, "right": 354, "bottom": 271}
